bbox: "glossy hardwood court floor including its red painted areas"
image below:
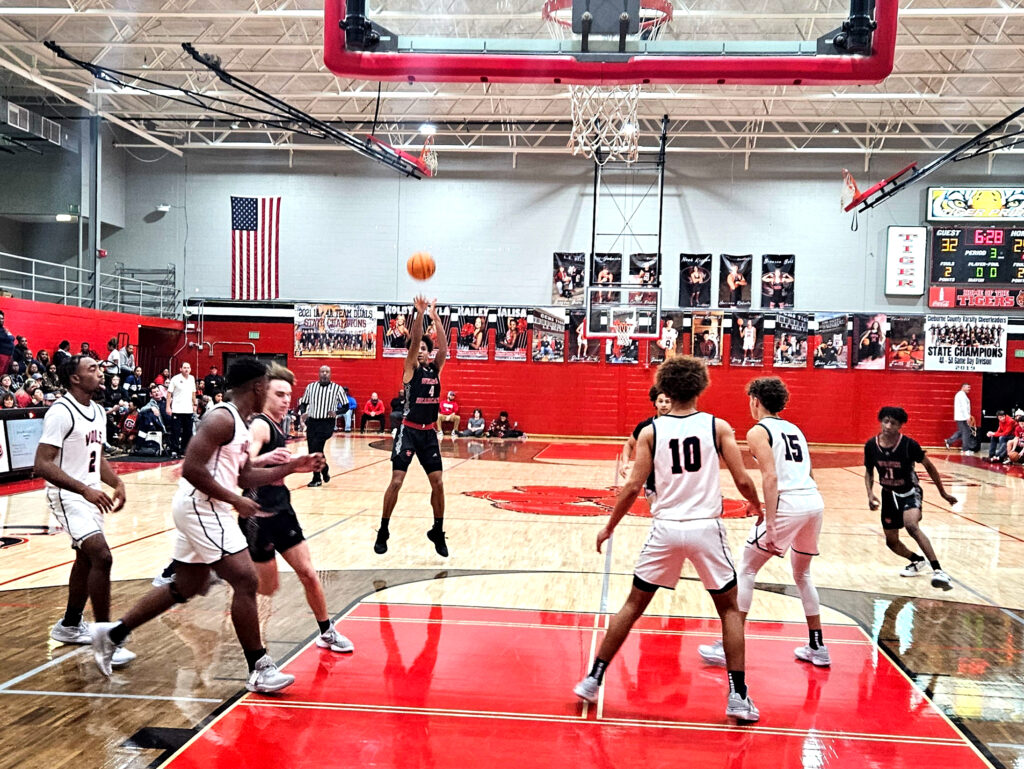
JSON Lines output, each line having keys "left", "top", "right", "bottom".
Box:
{"left": 0, "top": 436, "right": 1024, "bottom": 769}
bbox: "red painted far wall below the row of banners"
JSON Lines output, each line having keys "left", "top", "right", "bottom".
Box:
{"left": 198, "top": 321, "right": 983, "bottom": 445}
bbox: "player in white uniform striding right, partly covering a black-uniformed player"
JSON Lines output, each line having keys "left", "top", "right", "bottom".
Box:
{"left": 92, "top": 358, "right": 324, "bottom": 692}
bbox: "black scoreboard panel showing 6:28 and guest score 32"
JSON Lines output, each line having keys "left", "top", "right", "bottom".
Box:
{"left": 932, "top": 227, "right": 1024, "bottom": 288}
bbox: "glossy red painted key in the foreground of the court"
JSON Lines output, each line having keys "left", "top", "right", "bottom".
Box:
{"left": 169, "top": 604, "right": 988, "bottom": 769}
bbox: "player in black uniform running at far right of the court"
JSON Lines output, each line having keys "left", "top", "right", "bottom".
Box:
{"left": 864, "top": 405, "right": 956, "bottom": 590}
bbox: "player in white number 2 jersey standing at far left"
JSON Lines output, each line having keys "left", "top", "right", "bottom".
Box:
{"left": 35, "top": 355, "right": 135, "bottom": 668}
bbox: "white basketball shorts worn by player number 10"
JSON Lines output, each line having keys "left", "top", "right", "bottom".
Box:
{"left": 633, "top": 518, "right": 736, "bottom": 593}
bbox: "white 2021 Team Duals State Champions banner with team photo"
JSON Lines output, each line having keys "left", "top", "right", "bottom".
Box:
{"left": 295, "top": 304, "right": 377, "bottom": 358}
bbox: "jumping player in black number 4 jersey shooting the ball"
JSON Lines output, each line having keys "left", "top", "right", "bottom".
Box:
{"left": 374, "top": 296, "right": 447, "bottom": 558}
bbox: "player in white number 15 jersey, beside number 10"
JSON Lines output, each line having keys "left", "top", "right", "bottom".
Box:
{"left": 697, "top": 377, "right": 831, "bottom": 668}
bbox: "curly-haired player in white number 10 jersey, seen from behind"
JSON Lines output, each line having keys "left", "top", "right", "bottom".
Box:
{"left": 573, "top": 355, "right": 761, "bottom": 721}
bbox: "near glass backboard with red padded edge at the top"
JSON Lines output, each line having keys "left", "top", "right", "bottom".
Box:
{"left": 324, "top": 0, "right": 898, "bottom": 85}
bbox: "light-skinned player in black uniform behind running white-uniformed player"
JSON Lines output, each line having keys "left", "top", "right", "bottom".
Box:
{"left": 239, "top": 364, "right": 355, "bottom": 652}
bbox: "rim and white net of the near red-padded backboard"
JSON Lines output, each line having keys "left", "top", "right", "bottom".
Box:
{"left": 541, "top": 0, "right": 672, "bottom": 166}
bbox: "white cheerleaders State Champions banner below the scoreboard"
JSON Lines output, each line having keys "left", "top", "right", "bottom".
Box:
{"left": 925, "top": 315, "right": 1008, "bottom": 374}
